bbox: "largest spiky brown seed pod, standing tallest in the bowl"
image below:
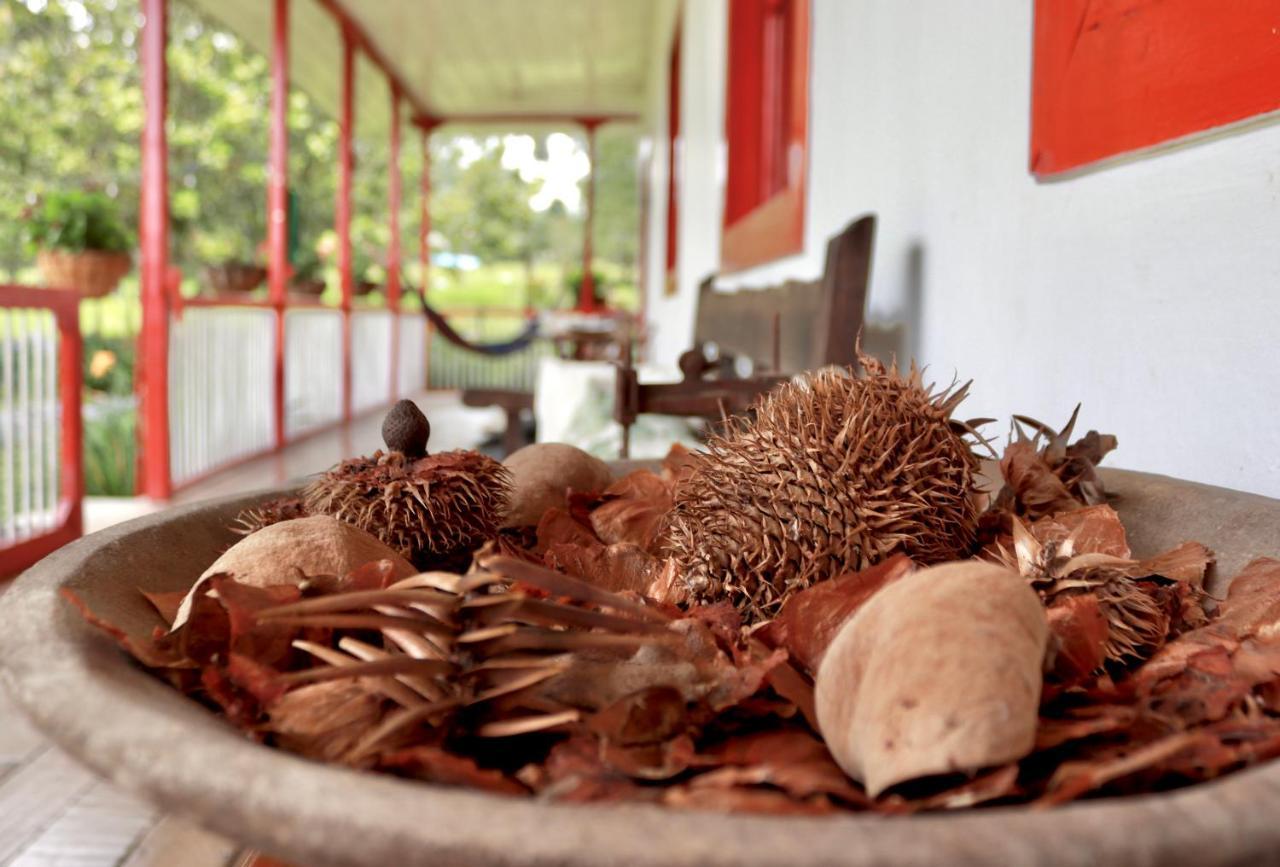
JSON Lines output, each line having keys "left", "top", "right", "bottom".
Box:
{"left": 663, "top": 357, "right": 978, "bottom": 621}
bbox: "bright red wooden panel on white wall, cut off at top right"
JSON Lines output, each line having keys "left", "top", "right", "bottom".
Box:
{"left": 1030, "top": 0, "right": 1280, "bottom": 178}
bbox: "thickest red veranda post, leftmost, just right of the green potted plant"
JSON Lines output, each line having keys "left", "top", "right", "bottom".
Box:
{"left": 138, "top": 0, "right": 173, "bottom": 499}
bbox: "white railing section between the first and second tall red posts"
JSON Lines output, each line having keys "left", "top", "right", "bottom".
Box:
{"left": 169, "top": 307, "right": 275, "bottom": 485}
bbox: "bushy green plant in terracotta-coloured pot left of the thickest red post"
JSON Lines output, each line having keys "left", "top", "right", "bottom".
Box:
{"left": 27, "top": 191, "right": 132, "bottom": 297}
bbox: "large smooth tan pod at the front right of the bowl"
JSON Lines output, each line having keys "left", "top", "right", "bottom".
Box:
{"left": 815, "top": 561, "right": 1048, "bottom": 797}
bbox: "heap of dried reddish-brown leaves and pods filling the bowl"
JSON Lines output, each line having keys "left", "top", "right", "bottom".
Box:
{"left": 65, "top": 386, "right": 1280, "bottom": 814}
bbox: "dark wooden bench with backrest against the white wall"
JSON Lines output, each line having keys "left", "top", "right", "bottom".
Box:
{"left": 614, "top": 214, "right": 876, "bottom": 457}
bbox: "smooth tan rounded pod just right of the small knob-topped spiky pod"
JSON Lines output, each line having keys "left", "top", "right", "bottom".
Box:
{"left": 503, "top": 443, "right": 613, "bottom": 526}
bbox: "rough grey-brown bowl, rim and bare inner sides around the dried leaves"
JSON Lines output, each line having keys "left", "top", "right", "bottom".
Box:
{"left": 0, "top": 471, "right": 1280, "bottom": 867}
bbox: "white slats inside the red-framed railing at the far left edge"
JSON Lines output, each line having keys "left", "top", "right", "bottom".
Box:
{"left": 0, "top": 307, "right": 61, "bottom": 546}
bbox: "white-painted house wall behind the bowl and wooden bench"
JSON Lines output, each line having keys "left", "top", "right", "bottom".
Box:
{"left": 652, "top": 0, "right": 1280, "bottom": 496}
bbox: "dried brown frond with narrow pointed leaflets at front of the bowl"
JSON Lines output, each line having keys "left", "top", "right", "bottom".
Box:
{"left": 257, "top": 557, "right": 684, "bottom": 763}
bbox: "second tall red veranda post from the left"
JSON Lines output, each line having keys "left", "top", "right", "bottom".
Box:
{"left": 266, "top": 0, "right": 289, "bottom": 448}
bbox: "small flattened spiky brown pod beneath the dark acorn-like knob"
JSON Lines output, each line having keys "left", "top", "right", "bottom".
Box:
{"left": 302, "top": 451, "right": 511, "bottom": 569}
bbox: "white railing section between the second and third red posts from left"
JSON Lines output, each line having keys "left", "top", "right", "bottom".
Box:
{"left": 284, "top": 309, "right": 342, "bottom": 439}
